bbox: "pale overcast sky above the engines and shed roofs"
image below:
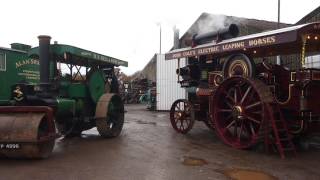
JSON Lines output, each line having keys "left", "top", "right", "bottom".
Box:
{"left": 0, "top": 0, "right": 320, "bottom": 74}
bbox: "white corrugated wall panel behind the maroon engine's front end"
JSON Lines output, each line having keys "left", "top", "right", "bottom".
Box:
{"left": 156, "top": 54, "right": 186, "bottom": 111}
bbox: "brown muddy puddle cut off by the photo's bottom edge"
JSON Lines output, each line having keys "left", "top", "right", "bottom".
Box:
{"left": 224, "top": 169, "right": 277, "bottom": 180}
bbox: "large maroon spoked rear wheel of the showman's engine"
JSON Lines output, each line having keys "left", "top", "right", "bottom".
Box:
{"left": 211, "top": 77, "right": 273, "bottom": 149}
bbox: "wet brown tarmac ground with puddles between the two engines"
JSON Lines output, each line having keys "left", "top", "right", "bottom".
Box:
{"left": 0, "top": 105, "right": 320, "bottom": 180}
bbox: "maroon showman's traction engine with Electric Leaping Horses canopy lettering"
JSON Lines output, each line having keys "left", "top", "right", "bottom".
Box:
{"left": 166, "top": 23, "right": 320, "bottom": 158}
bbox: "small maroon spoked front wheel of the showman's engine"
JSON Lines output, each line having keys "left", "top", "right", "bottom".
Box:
{"left": 170, "top": 99, "right": 195, "bottom": 134}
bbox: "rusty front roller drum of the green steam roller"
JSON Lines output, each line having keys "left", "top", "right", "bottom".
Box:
{"left": 0, "top": 107, "right": 56, "bottom": 159}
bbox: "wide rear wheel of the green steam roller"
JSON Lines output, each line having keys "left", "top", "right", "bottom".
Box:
{"left": 95, "top": 93, "right": 124, "bottom": 138}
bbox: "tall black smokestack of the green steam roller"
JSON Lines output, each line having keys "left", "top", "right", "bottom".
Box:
{"left": 38, "top": 35, "right": 51, "bottom": 85}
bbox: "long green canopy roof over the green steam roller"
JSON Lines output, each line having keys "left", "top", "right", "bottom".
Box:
{"left": 28, "top": 44, "right": 128, "bottom": 67}
